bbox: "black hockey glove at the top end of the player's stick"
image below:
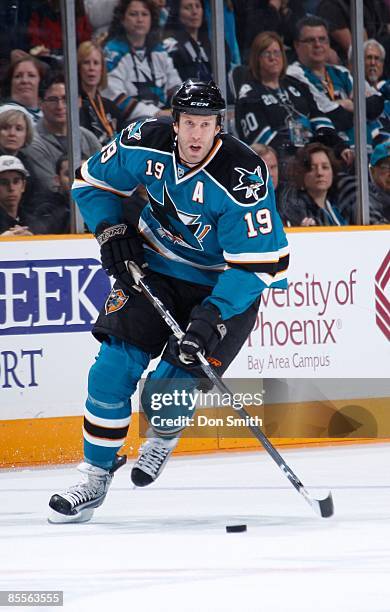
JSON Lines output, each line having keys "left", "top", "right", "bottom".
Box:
{"left": 95, "top": 221, "right": 148, "bottom": 293}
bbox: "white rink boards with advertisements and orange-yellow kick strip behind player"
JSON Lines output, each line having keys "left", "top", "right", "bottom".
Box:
{"left": 0, "top": 226, "right": 390, "bottom": 466}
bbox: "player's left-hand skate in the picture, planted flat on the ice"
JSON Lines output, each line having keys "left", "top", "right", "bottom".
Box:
{"left": 48, "top": 455, "right": 127, "bottom": 523}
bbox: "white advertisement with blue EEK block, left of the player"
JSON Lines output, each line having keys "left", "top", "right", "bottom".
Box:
{"left": 0, "top": 238, "right": 111, "bottom": 419}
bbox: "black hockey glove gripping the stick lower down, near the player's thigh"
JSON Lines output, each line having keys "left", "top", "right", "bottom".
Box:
{"left": 178, "top": 304, "right": 226, "bottom": 366}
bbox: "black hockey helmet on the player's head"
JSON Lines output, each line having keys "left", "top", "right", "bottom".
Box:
{"left": 172, "top": 79, "right": 226, "bottom": 123}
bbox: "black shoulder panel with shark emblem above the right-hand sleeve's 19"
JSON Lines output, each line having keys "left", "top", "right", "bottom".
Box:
{"left": 206, "top": 134, "right": 268, "bottom": 206}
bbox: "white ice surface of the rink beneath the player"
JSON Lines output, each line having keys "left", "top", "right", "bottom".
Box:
{"left": 0, "top": 444, "right": 390, "bottom": 612}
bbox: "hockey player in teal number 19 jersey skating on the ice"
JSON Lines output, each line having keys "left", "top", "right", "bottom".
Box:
{"left": 49, "top": 80, "right": 289, "bottom": 522}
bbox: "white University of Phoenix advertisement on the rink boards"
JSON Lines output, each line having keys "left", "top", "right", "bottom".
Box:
{"left": 228, "top": 228, "right": 390, "bottom": 379}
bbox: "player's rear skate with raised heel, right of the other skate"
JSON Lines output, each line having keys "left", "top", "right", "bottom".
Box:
{"left": 131, "top": 429, "right": 179, "bottom": 487}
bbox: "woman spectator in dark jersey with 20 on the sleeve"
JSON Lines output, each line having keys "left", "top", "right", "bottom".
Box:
{"left": 236, "top": 32, "right": 353, "bottom": 175}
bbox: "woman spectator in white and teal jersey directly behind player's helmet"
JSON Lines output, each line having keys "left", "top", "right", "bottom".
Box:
{"left": 103, "top": 0, "right": 181, "bottom": 119}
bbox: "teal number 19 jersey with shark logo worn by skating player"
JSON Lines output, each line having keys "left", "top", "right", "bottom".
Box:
{"left": 72, "top": 119, "right": 289, "bottom": 319}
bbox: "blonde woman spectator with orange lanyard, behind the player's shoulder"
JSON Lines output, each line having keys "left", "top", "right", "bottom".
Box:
{"left": 77, "top": 40, "right": 123, "bottom": 145}
